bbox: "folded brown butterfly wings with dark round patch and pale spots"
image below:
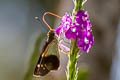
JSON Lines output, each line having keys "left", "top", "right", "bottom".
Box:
{"left": 33, "top": 31, "right": 60, "bottom": 77}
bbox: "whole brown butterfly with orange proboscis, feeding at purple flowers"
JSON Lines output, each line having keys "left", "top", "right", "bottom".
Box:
{"left": 33, "top": 12, "right": 61, "bottom": 77}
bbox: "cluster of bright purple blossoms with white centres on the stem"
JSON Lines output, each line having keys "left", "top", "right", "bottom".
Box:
{"left": 55, "top": 10, "right": 94, "bottom": 53}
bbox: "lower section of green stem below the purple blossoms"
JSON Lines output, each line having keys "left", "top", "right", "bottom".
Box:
{"left": 67, "top": 40, "right": 79, "bottom": 80}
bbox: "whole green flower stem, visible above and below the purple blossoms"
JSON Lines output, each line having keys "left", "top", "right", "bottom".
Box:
{"left": 67, "top": 0, "right": 84, "bottom": 80}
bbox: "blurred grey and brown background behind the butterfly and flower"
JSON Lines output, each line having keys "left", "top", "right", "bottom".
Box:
{"left": 0, "top": 0, "right": 120, "bottom": 80}
